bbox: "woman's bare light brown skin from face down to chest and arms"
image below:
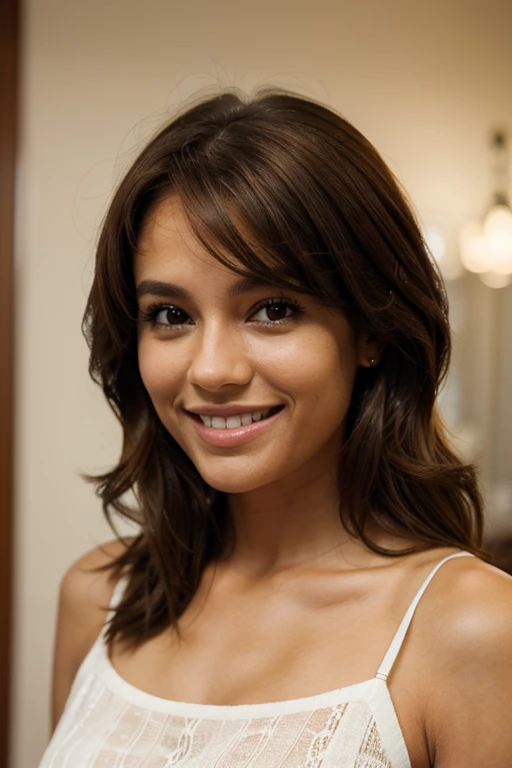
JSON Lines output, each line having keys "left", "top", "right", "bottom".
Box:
{"left": 53, "top": 196, "right": 512, "bottom": 768}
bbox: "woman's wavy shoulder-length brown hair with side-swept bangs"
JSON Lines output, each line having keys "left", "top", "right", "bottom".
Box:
{"left": 83, "top": 88, "right": 488, "bottom": 647}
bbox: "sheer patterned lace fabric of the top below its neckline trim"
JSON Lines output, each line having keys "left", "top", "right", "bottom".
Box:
{"left": 40, "top": 676, "right": 392, "bottom": 768}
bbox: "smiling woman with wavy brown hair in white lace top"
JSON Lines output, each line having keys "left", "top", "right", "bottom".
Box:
{"left": 42, "top": 89, "right": 512, "bottom": 768}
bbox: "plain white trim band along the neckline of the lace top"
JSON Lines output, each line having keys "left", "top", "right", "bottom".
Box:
{"left": 99, "top": 643, "right": 389, "bottom": 720}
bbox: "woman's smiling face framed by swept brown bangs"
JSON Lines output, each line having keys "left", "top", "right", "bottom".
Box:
{"left": 134, "top": 198, "right": 375, "bottom": 493}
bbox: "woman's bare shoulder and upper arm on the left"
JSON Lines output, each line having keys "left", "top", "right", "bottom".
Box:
{"left": 52, "top": 537, "right": 133, "bottom": 729}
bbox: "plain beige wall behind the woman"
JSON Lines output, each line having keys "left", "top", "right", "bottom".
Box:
{"left": 12, "top": 0, "right": 512, "bottom": 768}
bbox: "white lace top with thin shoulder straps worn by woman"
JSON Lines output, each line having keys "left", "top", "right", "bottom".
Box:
{"left": 39, "top": 552, "right": 471, "bottom": 768}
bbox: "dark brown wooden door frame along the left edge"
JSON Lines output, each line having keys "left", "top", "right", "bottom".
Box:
{"left": 0, "top": 0, "right": 21, "bottom": 768}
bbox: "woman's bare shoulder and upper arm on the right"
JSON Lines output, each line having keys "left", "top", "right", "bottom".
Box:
{"left": 417, "top": 557, "right": 512, "bottom": 768}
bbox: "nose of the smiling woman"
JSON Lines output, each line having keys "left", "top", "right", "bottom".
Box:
{"left": 187, "top": 322, "right": 252, "bottom": 392}
